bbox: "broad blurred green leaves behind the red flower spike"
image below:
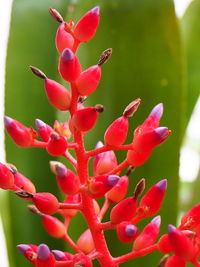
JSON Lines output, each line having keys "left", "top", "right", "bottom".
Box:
{"left": 1, "top": 0, "right": 200, "bottom": 267}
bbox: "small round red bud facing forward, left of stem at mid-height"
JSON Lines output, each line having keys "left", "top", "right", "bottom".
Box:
{"left": 46, "top": 132, "right": 68, "bottom": 156}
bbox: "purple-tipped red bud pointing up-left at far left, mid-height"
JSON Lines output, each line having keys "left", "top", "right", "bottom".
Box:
{"left": 4, "top": 116, "right": 37, "bottom": 147}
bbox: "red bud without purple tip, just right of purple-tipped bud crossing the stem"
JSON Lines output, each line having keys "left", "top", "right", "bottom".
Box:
{"left": 106, "top": 176, "right": 128, "bottom": 203}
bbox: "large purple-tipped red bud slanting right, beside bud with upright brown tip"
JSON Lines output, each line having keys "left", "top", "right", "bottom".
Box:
{"left": 137, "top": 180, "right": 167, "bottom": 218}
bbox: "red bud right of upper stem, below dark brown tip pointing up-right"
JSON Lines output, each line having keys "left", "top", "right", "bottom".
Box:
{"left": 76, "top": 65, "right": 101, "bottom": 96}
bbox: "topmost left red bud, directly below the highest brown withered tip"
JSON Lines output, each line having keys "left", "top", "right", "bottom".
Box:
{"left": 56, "top": 22, "right": 74, "bottom": 53}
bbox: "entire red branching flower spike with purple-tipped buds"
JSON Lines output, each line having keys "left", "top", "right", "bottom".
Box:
{"left": 0, "top": 7, "right": 200, "bottom": 267}
